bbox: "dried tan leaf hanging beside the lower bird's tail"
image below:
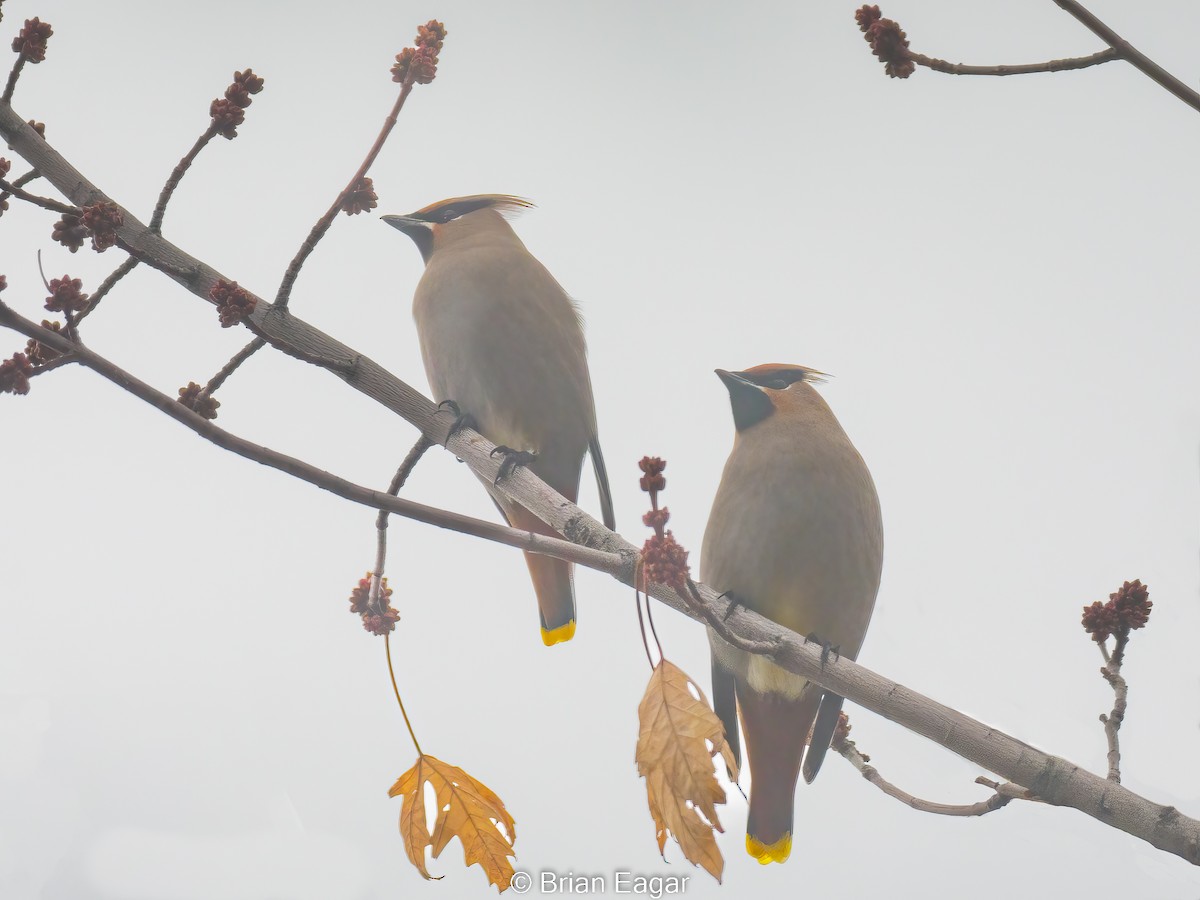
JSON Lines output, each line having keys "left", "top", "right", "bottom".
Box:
{"left": 636, "top": 660, "right": 737, "bottom": 881}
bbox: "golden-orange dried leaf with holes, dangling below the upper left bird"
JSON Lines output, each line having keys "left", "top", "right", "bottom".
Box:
{"left": 388, "top": 754, "right": 517, "bottom": 893}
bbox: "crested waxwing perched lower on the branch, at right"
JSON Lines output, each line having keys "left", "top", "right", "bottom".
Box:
{"left": 700, "top": 364, "right": 883, "bottom": 865}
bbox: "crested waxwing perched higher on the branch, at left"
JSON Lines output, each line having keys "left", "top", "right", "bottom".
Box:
{"left": 382, "top": 194, "right": 616, "bottom": 647}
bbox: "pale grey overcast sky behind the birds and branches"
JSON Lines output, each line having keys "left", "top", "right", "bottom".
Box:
{"left": 0, "top": 0, "right": 1200, "bottom": 900}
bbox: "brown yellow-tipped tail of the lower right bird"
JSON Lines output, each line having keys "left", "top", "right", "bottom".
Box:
{"left": 737, "top": 680, "right": 821, "bottom": 865}
